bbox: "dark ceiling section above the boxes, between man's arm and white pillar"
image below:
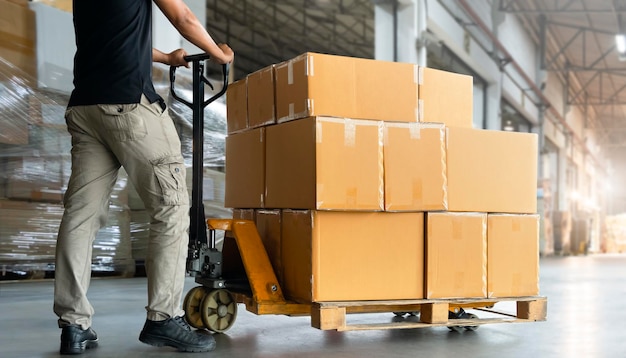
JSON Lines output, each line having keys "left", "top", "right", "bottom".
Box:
{"left": 206, "top": 0, "right": 374, "bottom": 79}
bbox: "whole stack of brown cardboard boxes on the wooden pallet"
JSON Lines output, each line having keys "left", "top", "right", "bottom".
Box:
{"left": 225, "top": 53, "right": 538, "bottom": 302}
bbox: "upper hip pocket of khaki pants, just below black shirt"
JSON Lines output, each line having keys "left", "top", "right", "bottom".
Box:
{"left": 98, "top": 103, "right": 148, "bottom": 142}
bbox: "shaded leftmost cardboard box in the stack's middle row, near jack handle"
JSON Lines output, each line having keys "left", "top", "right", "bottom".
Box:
{"left": 224, "top": 127, "right": 265, "bottom": 208}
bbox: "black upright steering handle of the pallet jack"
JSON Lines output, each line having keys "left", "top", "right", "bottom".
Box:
{"left": 170, "top": 53, "right": 230, "bottom": 250}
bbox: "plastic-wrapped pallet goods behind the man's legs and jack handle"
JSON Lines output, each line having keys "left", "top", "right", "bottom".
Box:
{"left": 0, "top": 57, "right": 228, "bottom": 279}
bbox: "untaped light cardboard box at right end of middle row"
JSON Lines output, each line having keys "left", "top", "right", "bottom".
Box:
{"left": 446, "top": 128, "right": 538, "bottom": 214}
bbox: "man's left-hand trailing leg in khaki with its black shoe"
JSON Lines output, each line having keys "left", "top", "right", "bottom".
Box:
{"left": 54, "top": 106, "right": 120, "bottom": 354}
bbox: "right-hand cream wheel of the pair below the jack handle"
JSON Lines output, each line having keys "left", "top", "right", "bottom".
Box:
{"left": 200, "top": 289, "right": 237, "bottom": 333}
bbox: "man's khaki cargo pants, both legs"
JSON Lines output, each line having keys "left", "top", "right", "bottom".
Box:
{"left": 54, "top": 96, "right": 189, "bottom": 329}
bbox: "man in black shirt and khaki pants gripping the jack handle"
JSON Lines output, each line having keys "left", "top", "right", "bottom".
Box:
{"left": 54, "top": 0, "right": 234, "bottom": 354}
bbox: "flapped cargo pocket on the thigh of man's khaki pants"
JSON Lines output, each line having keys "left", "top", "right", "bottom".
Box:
{"left": 151, "top": 156, "right": 189, "bottom": 205}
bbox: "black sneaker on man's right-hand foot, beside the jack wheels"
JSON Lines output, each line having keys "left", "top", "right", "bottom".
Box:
{"left": 139, "top": 317, "right": 215, "bottom": 352}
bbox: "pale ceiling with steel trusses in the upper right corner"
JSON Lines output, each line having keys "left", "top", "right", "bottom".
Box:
{"left": 498, "top": 0, "right": 626, "bottom": 170}
